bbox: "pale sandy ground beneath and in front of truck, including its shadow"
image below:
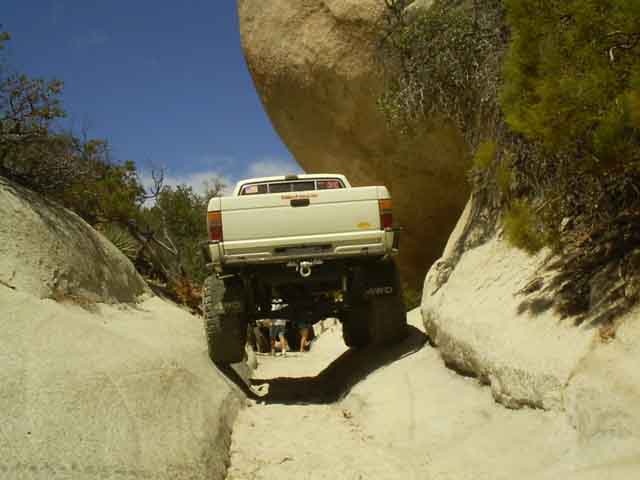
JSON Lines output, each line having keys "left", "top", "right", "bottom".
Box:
{"left": 227, "top": 311, "right": 623, "bottom": 480}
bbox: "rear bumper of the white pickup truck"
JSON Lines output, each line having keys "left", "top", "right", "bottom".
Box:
{"left": 203, "top": 228, "right": 400, "bottom": 271}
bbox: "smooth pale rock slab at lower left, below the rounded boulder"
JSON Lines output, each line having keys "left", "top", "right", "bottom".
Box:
{"left": 0, "top": 285, "right": 244, "bottom": 480}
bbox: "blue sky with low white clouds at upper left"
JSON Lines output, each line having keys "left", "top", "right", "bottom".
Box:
{"left": 0, "top": 0, "right": 300, "bottom": 193}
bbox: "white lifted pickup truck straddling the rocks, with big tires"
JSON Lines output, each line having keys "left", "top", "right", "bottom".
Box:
{"left": 203, "top": 174, "right": 406, "bottom": 363}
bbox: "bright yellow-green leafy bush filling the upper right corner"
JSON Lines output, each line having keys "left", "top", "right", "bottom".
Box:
{"left": 501, "top": 0, "right": 640, "bottom": 164}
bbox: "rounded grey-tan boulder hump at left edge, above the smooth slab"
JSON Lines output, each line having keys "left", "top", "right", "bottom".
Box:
{"left": 0, "top": 177, "right": 148, "bottom": 302}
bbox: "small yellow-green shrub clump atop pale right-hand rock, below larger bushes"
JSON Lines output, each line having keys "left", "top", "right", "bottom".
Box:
{"left": 503, "top": 200, "right": 545, "bottom": 254}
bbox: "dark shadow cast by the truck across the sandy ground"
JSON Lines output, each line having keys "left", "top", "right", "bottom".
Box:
{"left": 248, "top": 326, "right": 427, "bottom": 404}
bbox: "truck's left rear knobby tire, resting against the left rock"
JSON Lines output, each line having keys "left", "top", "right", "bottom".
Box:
{"left": 202, "top": 275, "right": 247, "bottom": 364}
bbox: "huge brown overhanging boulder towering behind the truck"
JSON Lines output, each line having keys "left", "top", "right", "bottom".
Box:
{"left": 238, "top": 0, "right": 469, "bottom": 286}
